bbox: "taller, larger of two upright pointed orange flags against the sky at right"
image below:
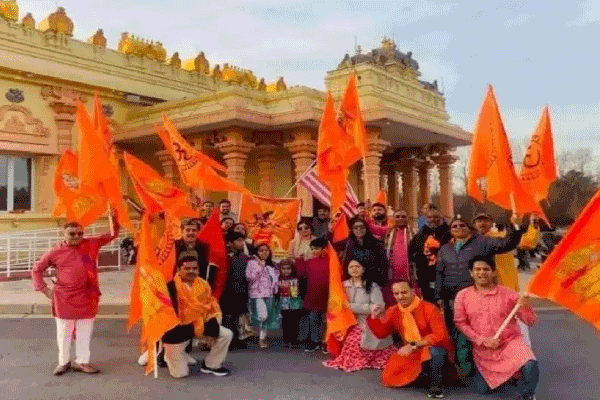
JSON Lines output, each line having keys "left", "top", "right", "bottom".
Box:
{"left": 467, "top": 85, "right": 546, "bottom": 218}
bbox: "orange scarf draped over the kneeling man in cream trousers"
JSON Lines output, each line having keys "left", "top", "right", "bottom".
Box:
{"left": 173, "top": 273, "right": 221, "bottom": 336}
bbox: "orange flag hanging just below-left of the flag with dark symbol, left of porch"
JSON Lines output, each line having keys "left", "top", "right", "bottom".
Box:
{"left": 124, "top": 153, "right": 198, "bottom": 218}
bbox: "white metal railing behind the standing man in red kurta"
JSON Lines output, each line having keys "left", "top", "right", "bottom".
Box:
{"left": 0, "top": 224, "right": 137, "bottom": 277}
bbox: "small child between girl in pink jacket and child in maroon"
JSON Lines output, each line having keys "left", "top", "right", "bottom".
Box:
{"left": 279, "top": 258, "right": 303, "bottom": 348}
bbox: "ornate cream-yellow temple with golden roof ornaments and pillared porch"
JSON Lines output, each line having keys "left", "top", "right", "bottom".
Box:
{"left": 0, "top": 4, "right": 471, "bottom": 231}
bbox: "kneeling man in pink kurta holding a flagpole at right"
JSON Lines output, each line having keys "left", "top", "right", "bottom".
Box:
{"left": 454, "top": 257, "right": 539, "bottom": 400}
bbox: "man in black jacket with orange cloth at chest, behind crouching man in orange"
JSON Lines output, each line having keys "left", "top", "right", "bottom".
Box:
{"left": 408, "top": 210, "right": 451, "bottom": 303}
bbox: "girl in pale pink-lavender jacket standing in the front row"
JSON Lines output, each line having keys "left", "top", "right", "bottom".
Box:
{"left": 246, "top": 244, "right": 280, "bottom": 349}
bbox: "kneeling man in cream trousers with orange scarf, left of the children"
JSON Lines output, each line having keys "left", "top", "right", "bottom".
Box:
{"left": 162, "top": 257, "right": 233, "bottom": 378}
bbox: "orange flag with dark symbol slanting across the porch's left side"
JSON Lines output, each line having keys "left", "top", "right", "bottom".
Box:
{"left": 155, "top": 114, "right": 250, "bottom": 194}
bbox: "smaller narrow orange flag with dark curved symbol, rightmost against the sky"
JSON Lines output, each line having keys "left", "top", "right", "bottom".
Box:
{"left": 520, "top": 106, "right": 558, "bottom": 202}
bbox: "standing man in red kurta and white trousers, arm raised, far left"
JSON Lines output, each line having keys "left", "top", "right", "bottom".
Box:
{"left": 31, "top": 216, "right": 119, "bottom": 375}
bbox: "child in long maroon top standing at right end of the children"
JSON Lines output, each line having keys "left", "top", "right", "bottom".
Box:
{"left": 297, "top": 238, "right": 329, "bottom": 353}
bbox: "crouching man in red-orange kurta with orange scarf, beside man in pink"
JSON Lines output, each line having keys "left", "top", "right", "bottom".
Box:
{"left": 367, "top": 281, "right": 453, "bottom": 399}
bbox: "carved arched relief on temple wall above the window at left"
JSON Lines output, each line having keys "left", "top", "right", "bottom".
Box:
{"left": 0, "top": 104, "right": 50, "bottom": 144}
